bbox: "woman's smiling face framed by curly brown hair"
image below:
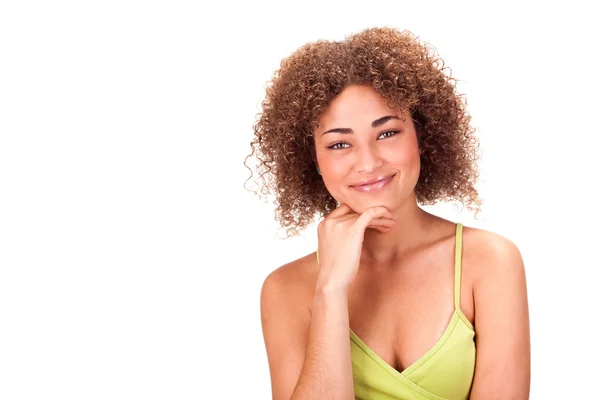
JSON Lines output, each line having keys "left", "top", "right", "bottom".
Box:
{"left": 315, "top": 85, "right": 421, "bottom": 213}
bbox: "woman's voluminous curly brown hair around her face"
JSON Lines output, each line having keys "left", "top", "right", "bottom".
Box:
{"left": 244, "top": 27, "right": 481, "bottom": 237}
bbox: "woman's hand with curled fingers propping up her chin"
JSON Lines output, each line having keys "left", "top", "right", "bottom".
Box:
{"left": 317, "top": 204, "right": 396, "bottom": 289}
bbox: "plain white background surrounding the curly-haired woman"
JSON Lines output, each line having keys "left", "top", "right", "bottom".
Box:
{"left": 0, "top": 1, "right": 600, "bottom": 400}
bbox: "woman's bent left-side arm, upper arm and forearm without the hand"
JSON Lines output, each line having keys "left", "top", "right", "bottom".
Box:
{"left": 261, "top": 270, "right": 354, "bottom": 400}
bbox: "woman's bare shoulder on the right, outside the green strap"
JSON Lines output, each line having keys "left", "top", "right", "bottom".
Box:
{"left": 463, "top": 227, "right": 524, "bottom": 284}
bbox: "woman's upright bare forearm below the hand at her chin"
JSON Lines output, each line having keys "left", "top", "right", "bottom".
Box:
{"left": 292, "top": 287, "right": 354, "bottom": 400}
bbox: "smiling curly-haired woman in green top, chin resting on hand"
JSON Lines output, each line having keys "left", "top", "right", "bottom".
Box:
{"left": 246, "top": 28, "right": 530, "bottom": 400}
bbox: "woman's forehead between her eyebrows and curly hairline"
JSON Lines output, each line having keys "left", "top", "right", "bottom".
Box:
{"left": 318, "top": 85, "right": 405, "bottom": 130}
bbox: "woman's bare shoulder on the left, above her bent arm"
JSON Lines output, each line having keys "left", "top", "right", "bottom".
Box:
{"left": 261, "top": 252, "right": 318, "bottom": 316}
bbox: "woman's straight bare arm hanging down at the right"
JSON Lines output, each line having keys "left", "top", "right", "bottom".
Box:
{"left": 471, "top": 235, "right": 531, "bottom": 400}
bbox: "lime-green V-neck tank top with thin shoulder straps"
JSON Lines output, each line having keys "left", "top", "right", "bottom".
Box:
{"left": 317, "top": 224, "right": 475, "bottom": 400}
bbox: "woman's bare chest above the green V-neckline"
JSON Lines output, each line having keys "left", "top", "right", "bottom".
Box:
{"left": 348, "top": 263, "right": 472, "bottom": 372}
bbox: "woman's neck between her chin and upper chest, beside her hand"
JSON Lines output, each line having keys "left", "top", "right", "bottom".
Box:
{"left": 361, "top": 193, "right": 438, "bottom": 265}
